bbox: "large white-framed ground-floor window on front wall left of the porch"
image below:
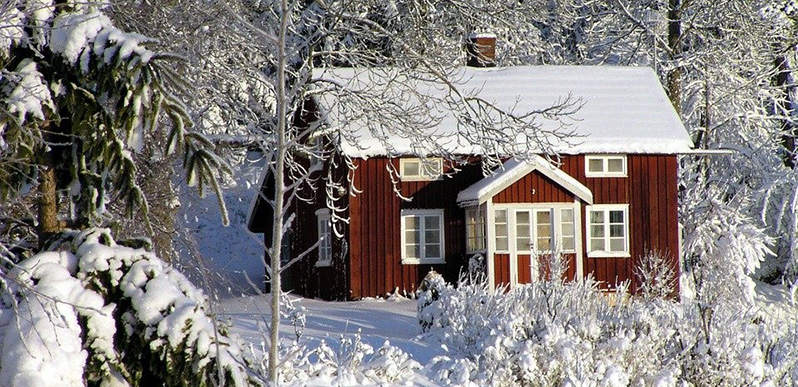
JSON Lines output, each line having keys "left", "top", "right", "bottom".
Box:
{"left": 402, "top": 209, "right": 445, "bottom": 265}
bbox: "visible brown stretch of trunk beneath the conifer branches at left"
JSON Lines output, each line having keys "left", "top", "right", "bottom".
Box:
{"left": 37, "top": 146, "right": 62, "bottom": 249}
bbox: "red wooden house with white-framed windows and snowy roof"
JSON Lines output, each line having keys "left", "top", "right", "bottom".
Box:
{"left": 249, "top": 66, "right": 692, "bottom": 299}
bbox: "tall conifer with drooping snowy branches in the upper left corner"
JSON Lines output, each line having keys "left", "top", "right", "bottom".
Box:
{"left": 0, "top": 0, "right": 227, "bottom": 249}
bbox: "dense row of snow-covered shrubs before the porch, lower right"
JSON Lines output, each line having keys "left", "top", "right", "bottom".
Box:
{"left": 419, "top": 272, "right": 798, "bottom": 387}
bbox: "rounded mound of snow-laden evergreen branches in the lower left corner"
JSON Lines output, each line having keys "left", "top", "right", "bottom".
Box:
{"left": 0, "top": 229, "right": 257, "bottom": 387}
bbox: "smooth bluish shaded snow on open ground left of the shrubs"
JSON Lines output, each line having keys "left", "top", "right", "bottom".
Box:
{"left": 220, "top": 295, "right": 444, "bottom": 365}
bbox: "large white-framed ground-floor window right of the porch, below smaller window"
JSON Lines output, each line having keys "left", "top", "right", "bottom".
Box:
{"left": 587, "top": 204, "right": 630, "bottom": 257}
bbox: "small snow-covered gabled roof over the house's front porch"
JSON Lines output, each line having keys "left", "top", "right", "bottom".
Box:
{"left": 457, "top": 156, "right": 593, "bottom": 207}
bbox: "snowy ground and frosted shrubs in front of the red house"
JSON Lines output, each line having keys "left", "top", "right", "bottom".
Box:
{"left": 221, "top": 283, "right": 798, "bottom": 387}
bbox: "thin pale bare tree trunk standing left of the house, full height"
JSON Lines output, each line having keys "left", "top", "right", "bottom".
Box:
{"left": 269, "top": 0, "right": 289, "bottom": 386}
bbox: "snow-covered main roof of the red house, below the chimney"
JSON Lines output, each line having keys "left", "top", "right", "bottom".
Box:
{"left": 314, "top": 66, "right": 692, "bottom": 158}
